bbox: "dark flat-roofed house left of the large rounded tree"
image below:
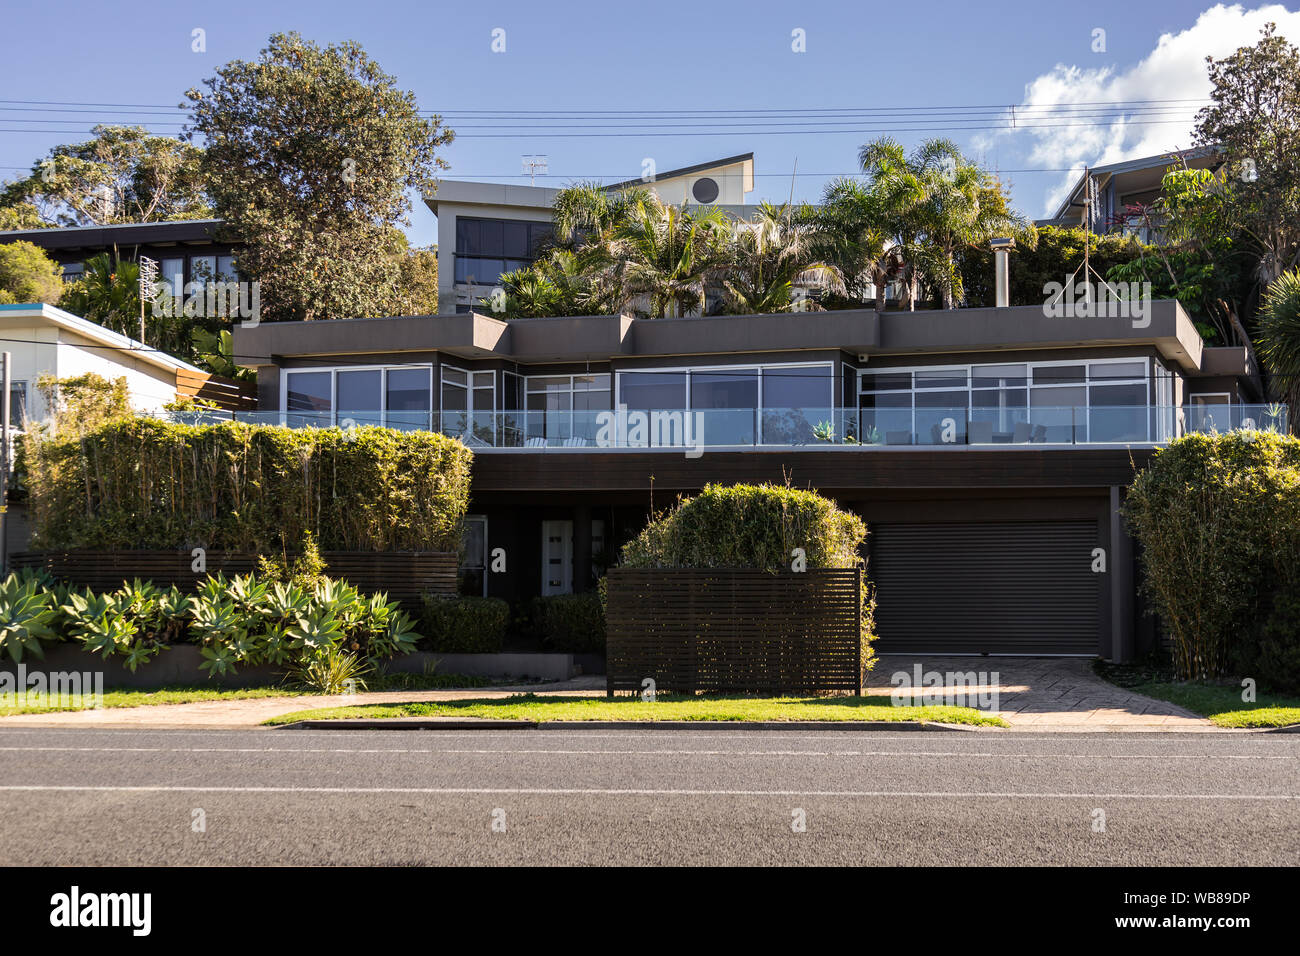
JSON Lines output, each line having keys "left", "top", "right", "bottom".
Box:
{"left": 0, "top": 219, "right": 242, "bottom": 295}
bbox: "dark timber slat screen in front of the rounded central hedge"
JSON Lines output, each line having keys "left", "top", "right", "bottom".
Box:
{"left": 606, "top": 568, "right": 862, "bottom": 696}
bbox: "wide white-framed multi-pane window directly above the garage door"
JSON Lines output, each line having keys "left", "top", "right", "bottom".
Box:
{"left": 858, "top": 359, "right": 1161, "bottom": 445}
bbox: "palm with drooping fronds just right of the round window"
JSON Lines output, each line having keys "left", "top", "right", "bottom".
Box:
{"left": 722, "top": 203, "right": 844, "bottom": 315}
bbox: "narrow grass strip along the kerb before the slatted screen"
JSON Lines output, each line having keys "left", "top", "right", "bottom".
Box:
{"left": 267, "top": 693, "right": 1008, "bottom": 727}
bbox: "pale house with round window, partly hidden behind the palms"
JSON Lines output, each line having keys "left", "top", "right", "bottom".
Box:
{"left": 425, "top": 152, "right": 758, "bottom": 313}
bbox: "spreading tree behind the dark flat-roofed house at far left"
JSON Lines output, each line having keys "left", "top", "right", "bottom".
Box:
{"left": 0, "top": 126, "right": 212, "bottom": 228}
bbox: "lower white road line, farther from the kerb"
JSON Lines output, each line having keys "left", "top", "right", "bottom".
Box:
{"left": 0, "top": 784, "right": 1300, "bottom": 801}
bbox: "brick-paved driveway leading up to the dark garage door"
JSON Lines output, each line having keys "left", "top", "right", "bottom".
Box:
{"left": 867, "top": 654, "right": 1211, "bottom": 732}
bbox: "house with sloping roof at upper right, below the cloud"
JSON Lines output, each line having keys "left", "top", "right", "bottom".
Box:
{"left": 1036, "top": 147, "right": 1223, "bottom": 242}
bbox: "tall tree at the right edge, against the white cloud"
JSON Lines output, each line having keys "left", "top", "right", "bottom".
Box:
{"left": 1175, "top": 23, "right": 1300, "bottom": 286}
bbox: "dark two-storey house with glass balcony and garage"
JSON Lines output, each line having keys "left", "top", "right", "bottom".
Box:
{"left": 234, "top": 295, "right": 1286, "bottom": 659}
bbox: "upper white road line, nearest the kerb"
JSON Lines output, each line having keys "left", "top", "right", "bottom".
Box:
{"left": 0, "top": 747, "right": 1284, "bottom": 760}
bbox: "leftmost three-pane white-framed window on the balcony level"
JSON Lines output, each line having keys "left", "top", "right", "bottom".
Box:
{"left": 281, "top": 365, "right": 433, "bottom": 429}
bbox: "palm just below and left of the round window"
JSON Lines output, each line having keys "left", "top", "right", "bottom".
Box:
{"left": 607, "top": 193, "right": 731, "bottom": 319}
